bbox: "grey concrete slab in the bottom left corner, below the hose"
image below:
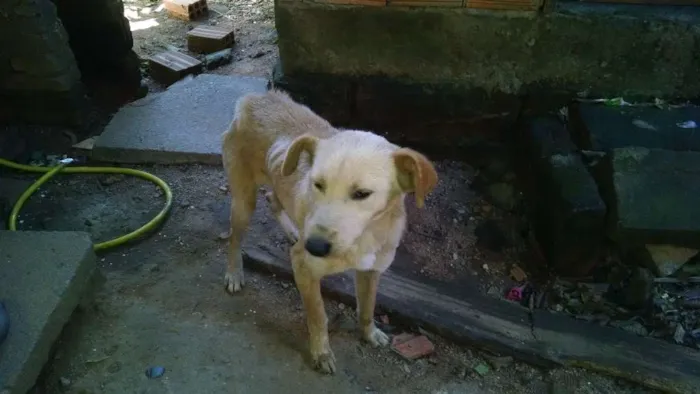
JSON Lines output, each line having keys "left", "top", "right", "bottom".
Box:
{"left": 0, "top": 231, "right": 98, "bottom": 394}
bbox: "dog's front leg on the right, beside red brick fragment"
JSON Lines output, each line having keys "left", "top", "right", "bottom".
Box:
{"left": 355, "top": 271, "right": 389, "bottom": 347}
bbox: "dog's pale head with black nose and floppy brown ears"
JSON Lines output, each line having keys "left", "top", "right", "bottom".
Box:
{"left": 282, "top": 130, "right": 437, "bottom": 257}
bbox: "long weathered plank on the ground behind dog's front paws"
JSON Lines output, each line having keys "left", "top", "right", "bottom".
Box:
{"left": 244, "top": 246, "right": 700, "bottom": 394}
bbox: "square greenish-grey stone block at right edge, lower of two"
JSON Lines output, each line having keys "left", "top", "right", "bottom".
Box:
{"left": 609, "top": 147, "right": 700, "bottom": 248}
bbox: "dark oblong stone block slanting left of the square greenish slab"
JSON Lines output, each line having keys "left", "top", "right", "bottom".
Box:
{"left": 520, "top": 116, "right": 607, "bottom": 277}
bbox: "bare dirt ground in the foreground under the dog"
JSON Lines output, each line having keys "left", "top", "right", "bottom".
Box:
{"left": 0, "top": 161, "right": 642, "bottom": 394}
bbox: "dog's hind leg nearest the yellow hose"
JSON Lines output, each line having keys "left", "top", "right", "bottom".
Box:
{"left": 224, "top": 162, "right": 257, "bottom": 293}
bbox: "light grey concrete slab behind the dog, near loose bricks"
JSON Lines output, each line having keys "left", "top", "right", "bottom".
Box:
{"left": 92, "top": 74, "right": 267, "bottom": 165}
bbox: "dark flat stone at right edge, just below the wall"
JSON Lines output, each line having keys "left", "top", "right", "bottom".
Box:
{"left": 569, "top": 103, "right": 700, "bottom": 152}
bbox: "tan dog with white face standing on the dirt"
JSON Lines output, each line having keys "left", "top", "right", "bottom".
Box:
{"left": 222, "top": 91, "right": 437, "bottom": 373}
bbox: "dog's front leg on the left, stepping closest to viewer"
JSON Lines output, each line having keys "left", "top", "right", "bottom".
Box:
{"left": 292, "top": 242, "right": 335, "bottom": 374}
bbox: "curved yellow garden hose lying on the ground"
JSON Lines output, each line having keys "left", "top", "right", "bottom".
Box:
{"left": 0, "top": 158, "right": 173, "bottom": 251}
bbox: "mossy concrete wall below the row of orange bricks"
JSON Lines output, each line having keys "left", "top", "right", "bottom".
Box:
{"left": 276, "top": 0, "right": 700, "bottom": 98}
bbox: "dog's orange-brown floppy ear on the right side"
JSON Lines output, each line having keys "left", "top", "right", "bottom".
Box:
{"left": 393, "top": 148, "right": 437, "bottom": 208}
